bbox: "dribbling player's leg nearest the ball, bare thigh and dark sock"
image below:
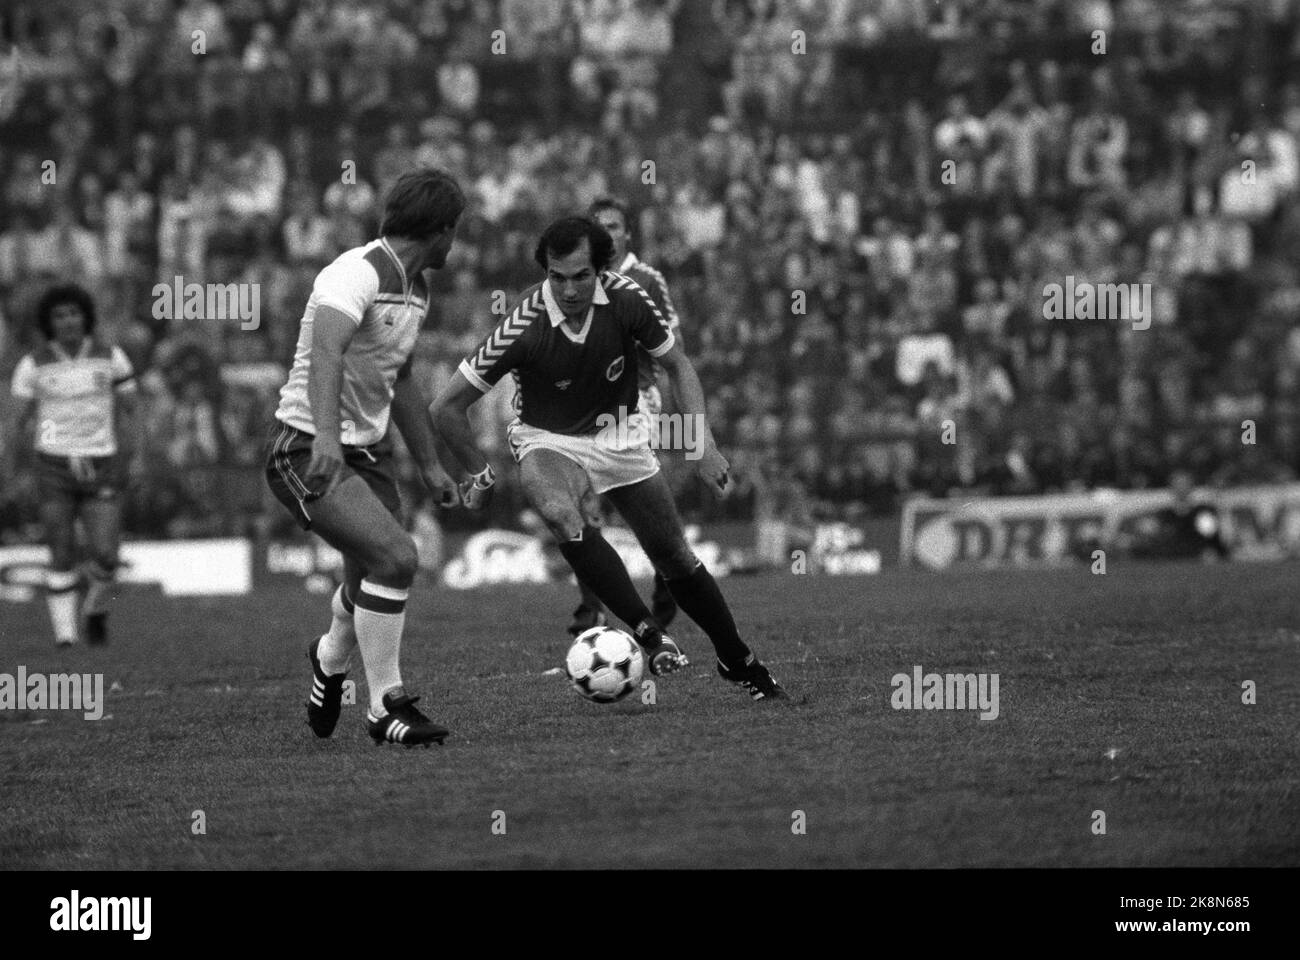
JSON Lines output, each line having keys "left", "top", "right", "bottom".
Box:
{"left": 519, "top": 449, "right": 688, "bottom": 674}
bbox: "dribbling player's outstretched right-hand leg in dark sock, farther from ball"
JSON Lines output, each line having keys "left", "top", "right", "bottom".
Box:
{"left": 606, "top": 472, "right": 788, "bottom": 700}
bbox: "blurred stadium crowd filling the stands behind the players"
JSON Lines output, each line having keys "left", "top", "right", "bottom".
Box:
{"left": 0, "top": 0, "right": 1300, "bottom": 539}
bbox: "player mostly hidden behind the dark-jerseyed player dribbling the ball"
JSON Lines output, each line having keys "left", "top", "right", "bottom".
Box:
{"left": 569, "top": 196, "right": 685, "bottom": 636}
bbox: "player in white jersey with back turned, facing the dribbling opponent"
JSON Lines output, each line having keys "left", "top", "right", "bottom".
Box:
{"left": 267, "top": 169, "right": 465, "bottom": 745}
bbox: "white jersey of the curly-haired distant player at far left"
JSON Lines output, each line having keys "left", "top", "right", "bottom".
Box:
{"left": 10, "top": 337, "right": 135, "bottom": 457}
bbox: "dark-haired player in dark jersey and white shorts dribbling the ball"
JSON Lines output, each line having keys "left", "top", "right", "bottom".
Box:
{"left": 430, "top": 217, "right": 787, "bottom": 700}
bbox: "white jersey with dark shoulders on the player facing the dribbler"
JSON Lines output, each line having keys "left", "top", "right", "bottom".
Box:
{"left": 276, "top": 238, "right": 429, "bottom": 446}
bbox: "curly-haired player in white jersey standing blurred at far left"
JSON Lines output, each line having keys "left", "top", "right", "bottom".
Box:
{"left": 12, "top": 285, "right": 135, "bottom": 645}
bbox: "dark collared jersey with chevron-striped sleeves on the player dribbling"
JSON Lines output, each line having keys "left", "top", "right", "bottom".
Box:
{"left": 459, "top": 271, "right": 675, "bottom": 434}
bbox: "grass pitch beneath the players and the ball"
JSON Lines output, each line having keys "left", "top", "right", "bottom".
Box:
{"left": 0, "top": 563, "right": 1300, "bottom": 869}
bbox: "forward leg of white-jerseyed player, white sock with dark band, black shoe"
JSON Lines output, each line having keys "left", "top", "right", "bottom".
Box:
{"left": 307, "top": 475, "right": 447, "bottom": 744}
